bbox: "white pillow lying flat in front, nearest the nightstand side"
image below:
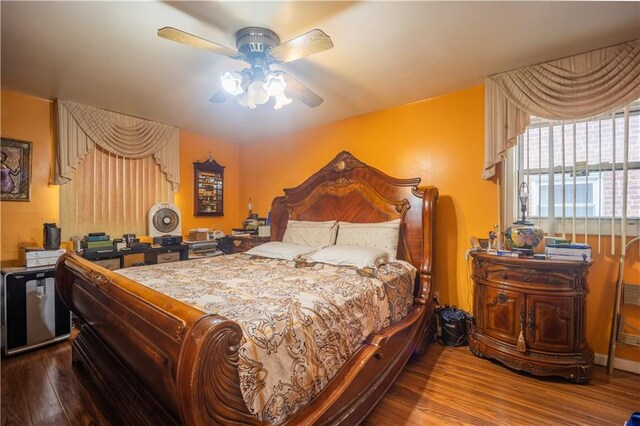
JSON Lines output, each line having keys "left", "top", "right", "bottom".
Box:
{"left": 307, "top": 246, "right": 389, "bottom": 268}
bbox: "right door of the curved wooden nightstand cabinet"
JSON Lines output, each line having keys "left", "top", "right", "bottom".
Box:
{"left": 527, "top": 295, "right": 575, "bottom": 352}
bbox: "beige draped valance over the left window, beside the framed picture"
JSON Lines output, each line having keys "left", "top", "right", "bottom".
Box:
{"left": 51, "top": 99, "right": 180, "bottom": 192}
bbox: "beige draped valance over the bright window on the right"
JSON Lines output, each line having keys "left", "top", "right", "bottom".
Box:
{"left": 482, "top": 39, "right": 640, "bottom": 179}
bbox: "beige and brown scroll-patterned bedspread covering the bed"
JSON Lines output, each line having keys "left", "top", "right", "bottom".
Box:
{"left": 117, "top": 254, "right": 415, "bottom": 424}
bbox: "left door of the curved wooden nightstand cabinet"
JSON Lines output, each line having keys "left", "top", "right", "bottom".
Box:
{"left": 482, "top": 286, "right": 524, "bottom": 345}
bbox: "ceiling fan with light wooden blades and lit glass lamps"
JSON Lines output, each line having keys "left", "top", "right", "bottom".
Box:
{"left": 158, "top": 27, "right": 333, "bottom": 109}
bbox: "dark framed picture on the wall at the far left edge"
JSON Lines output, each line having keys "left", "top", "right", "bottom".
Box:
{"left": 0, "top": 138, "right": 31, "bottom": 201}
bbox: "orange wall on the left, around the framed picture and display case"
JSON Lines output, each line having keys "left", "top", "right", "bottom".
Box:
{"left": 0, "top": 91, "right": 244, "bottom": 265}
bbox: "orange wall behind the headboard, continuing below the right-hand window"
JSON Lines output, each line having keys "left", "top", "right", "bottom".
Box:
{"left": 240, "top": 87, "right": 640, "bottom": 360}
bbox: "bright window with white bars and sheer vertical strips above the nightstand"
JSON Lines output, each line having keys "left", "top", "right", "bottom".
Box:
{"left": 512, "top": 102, "right": 640, "bottom": 240}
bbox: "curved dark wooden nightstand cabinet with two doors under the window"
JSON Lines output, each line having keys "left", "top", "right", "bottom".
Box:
{"left": 469, "top": 252, "right": 593, "bottom": 383}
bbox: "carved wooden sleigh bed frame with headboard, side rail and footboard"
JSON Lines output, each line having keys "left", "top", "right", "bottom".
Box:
{"left": 56, "top": 152, "right": 438, "bottom": 425}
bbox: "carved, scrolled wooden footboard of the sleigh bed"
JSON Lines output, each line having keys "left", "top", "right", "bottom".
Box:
{"left": 56, "top": 255, "right": 258, "bottom": 425}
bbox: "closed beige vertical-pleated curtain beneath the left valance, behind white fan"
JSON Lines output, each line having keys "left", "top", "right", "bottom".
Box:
{"left": 60, "top": 148, "right": 174, "bottom": 240}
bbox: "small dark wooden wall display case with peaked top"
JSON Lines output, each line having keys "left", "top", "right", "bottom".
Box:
{"left": 193, "top": 156, "right": 224, "bottom": 216}
